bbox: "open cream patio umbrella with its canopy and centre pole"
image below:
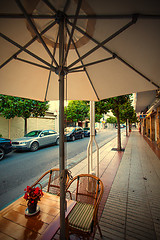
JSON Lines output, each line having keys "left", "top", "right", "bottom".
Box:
{"left": 0, "top": 0, "right": 160, "bottom": 239}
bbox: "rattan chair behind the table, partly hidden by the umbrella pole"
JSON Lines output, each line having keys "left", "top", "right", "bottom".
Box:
{"left": 32, "top": 168, "right": 70, "bottom": 195}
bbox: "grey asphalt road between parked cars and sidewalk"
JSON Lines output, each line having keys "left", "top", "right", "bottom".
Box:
{"left": 0, "top": 129, "right": 117, "bottom": 209}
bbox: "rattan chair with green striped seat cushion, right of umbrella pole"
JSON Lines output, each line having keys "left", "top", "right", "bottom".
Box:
{"left": 67, "top": 174, "right": 104, "bottom": 239}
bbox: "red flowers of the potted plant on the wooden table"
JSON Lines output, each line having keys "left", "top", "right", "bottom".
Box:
{"left": 24, "top": 185, "right": 43, "bottom": 206}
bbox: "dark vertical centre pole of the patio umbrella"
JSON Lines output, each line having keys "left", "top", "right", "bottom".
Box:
{"left": 59, "top": 14, "right": 66, "bottom": 240}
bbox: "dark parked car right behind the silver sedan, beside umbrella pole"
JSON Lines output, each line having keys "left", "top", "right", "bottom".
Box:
{"left": 64, "top": 127, "right": 84, "bottom": 141}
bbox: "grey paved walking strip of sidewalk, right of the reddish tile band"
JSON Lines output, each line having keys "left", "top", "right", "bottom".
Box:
{"left": 95, "top": 131, "right": 160, "bottom": 240}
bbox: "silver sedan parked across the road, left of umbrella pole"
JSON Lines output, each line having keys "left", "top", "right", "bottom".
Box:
{"left": 12, "top": 130, "right": 59, "bottom": 152}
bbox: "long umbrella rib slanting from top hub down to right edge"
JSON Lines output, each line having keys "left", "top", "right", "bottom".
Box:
{"left": 68, "top": 18, "right": 159, "bottom": 88}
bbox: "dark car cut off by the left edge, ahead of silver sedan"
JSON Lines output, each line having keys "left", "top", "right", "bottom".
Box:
{"left": 0, "top": 138, "right": 12, "bottom": 160}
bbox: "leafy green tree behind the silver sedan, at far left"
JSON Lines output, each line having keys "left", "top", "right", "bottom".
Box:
{"left": 0, "top": 94, "right": 49, "bottom": 134}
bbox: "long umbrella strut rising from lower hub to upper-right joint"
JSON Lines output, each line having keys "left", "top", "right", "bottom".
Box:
{"left": 68, "top": 17, "right": 137, "bottom": 68}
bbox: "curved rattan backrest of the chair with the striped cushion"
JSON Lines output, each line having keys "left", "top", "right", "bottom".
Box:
{"left": 67, "top": 174, "right": 104, "bottom": 223}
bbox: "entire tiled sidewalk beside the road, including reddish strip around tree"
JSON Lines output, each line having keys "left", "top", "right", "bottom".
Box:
{"left": 53, "top": 131, "right": 160, "bottom": 240}
